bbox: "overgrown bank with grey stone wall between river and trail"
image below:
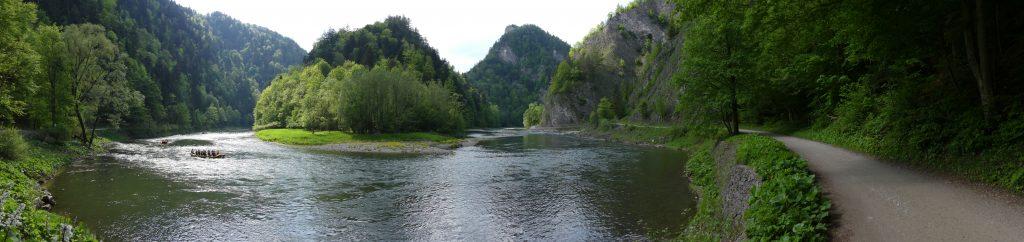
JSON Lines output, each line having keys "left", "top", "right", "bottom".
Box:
{"left": 678, "top": 134, "right": 831, "bottom": 241}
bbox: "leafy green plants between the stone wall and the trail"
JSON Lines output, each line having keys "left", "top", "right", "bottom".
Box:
{"left": 730, "top": 134, "right": 831, "bottom": 241}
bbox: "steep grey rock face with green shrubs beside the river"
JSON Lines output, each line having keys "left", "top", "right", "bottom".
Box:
{"left": 543, "top": 0, "right": 683, "bottom": 127}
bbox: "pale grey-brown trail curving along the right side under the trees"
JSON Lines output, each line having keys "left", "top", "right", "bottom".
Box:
{"left": 745, "top": 131, "right": 1024, "bottom": 241}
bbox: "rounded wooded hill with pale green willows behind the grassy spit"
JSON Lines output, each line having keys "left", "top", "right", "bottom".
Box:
{"left": 254, "top": 16, "right": 498, "bottom": 133}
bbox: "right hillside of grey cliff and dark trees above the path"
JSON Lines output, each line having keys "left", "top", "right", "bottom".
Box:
{"left": 548, "top": 0, "right": 1024, "bottom": 196}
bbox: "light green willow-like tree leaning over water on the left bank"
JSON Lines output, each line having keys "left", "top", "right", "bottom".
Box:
{"left": 63, "top": 24, "right": 142, "bottom": 146}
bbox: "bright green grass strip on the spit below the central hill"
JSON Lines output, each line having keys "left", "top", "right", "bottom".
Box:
{"left": 256, "top": 128, "right": 461, "bottom": 147}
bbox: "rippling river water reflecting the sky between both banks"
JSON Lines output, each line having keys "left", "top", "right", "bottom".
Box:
{"left": 50, "top": 130, "right": 695, "bottom": 241}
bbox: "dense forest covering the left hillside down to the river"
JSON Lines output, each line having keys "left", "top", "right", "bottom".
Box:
{"left": 0, "top": 0, "right": 305, "bottom": 143}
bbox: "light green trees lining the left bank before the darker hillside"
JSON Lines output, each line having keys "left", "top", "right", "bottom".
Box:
{"left": 0, "top": 0, "right": 145, "bottom": 145}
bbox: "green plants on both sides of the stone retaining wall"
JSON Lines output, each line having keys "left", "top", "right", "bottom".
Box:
{"left": 680, "top": 134, "right": 831, "bottom": 241}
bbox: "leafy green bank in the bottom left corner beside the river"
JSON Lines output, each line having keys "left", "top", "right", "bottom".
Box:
{"left": 0, "top": 130, "right": 102, "bottom": 238}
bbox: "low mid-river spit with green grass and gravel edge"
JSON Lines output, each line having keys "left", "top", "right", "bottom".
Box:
{"left": 256, "top": 129, "right": 464, "bottom": 155}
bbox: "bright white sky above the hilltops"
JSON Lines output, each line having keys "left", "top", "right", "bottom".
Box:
{"left": 174, "top": 0, "right": 631, "bottom": 72}
